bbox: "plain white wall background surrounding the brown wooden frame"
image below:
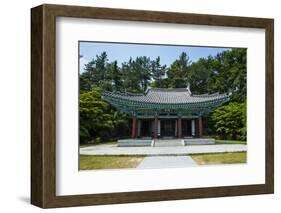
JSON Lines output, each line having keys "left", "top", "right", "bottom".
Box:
{"left": 0, "top": 0, "right": 281, "bottom": 213}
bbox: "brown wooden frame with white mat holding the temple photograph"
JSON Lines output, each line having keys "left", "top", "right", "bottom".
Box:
{"left": 31, "top": 5, "right": 274, "bottom": 208}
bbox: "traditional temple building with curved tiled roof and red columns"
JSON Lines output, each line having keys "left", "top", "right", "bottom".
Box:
{"left": 102, "top": 87, "right": 229, "bottom": 139}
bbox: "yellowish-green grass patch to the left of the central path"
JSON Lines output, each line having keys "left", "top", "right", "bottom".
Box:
{"left": 80, "top": 155, "right": 144, "bottom": 170}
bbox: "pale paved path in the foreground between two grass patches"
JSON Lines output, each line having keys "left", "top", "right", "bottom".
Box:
{"left": 137, "top": 156, "right": 197, "bottom": 169}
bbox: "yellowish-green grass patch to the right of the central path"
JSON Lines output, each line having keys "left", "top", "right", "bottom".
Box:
{"left": 190, "top": 152, "right": 247, "bottom": 165}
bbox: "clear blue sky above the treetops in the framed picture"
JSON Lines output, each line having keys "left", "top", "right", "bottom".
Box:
{"left": 79, "top": 41, "right": 230, "bottom": 72}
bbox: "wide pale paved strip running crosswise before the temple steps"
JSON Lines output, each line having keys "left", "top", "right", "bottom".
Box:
{"left": 80, "top": 144, "right": 247, "bottom": 156}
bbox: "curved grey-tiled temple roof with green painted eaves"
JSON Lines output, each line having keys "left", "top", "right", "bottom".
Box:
{"left": 102, "top": 88, "right": 229, "bottom": 117}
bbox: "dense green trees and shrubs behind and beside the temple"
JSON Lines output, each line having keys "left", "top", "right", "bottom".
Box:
{"left": 80, "top": 49, "right": 246, "bottom": 142}
